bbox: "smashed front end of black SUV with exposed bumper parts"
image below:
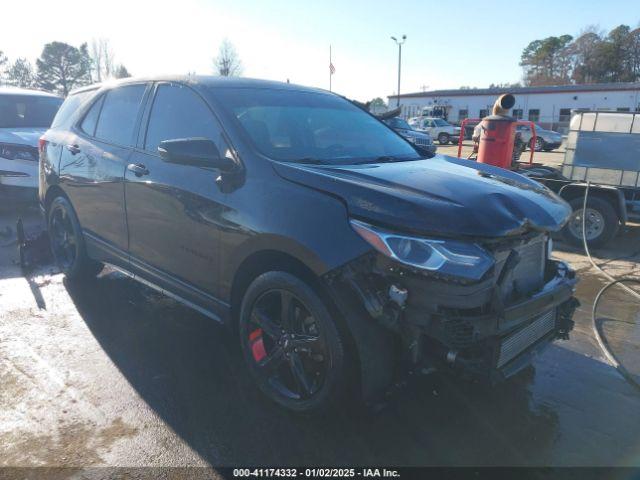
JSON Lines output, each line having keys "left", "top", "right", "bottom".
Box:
{"left": 326, "top": 236, "right": 578, "bottom": 398}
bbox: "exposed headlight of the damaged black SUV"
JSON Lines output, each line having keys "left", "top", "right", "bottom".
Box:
{"left": 350, "top": 220, "right": 494, "bottom": 280}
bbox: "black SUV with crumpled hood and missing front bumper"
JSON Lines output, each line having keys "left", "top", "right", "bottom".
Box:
{"left": 40, "top": 76, "right": 575, "bottom": 412}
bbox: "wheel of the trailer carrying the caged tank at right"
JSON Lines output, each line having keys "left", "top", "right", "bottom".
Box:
{"left": 562, "top": 196, "right": 620, "bottom": 248}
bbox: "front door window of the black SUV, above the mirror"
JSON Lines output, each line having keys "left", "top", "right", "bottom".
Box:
{"left": 144, "top": 84, "right": 227, "bottom": 155}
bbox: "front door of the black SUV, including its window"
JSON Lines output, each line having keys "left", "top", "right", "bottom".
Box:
{"left": 125, "top": 83, "right": 231, "bottom": 304}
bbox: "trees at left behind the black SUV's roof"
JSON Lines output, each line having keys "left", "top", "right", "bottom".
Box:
{"left": 0, "top": 39, "right": 131, "bottom": 96}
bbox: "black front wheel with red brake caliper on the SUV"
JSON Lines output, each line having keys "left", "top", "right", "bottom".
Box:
{"left": 239, "top": 271, "right": 350, "bottom": 414}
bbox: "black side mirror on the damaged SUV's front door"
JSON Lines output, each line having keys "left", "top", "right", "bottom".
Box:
{"left": 158, "top": 138, "right": 236, "bottom": 172}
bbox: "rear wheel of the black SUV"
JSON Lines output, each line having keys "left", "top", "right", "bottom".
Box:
{"left": 47, "top": 197, "right": 103, "bottom": 280}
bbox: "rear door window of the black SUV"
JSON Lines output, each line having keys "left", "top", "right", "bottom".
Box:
{"left": 96, "top": 84, "right": 146, "bottom": 145}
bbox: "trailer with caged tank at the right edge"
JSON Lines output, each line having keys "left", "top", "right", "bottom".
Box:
{"left": 519, "top": 110, "right": 640, "bottom": 247}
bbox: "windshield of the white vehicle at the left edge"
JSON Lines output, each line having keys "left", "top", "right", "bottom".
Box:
{"left": 0, "top": 95, "right": 62, "bottom": 128}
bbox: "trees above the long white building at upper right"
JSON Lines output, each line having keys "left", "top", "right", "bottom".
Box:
{"left": 520, "top": 25, "right": 640, "bottom": 86}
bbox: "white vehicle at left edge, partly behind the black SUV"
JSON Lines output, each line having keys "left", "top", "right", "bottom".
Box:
{"left": 0, "top": 87, "right": 62, "bottom": 201}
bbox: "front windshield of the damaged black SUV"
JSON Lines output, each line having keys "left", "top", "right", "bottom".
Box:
{"left": 212, "top": 88, "right": 420, "bottom": 165}
